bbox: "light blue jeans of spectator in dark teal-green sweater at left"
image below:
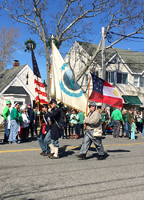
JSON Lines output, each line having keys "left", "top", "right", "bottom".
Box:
{"left": 9, "top": 120, "right": 18, "bottom": 142}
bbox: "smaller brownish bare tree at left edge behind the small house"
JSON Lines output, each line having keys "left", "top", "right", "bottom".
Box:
{"left": 0, "top": 26, "right": 20, "bottom": 71}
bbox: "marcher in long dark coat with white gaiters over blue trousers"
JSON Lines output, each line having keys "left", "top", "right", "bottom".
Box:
{"left": 45, "top": 99, "right": 61, "bottom": 159}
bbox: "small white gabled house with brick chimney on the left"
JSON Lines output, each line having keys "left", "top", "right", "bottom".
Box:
{"left": 0, "top": 60, "right": 35, "bottom": 123}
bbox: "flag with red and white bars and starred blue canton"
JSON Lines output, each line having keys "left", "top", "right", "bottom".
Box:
{"left": 89, "top": 73, "right": 123, "bottom": 108}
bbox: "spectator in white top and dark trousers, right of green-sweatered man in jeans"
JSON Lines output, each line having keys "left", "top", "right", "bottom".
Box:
{"left": 20, "top": 105, "right": 30, "bottom": 142}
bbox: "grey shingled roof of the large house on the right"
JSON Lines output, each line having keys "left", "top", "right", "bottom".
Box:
{"left": 76, "top": 41, "right": 144, "bottom": 73}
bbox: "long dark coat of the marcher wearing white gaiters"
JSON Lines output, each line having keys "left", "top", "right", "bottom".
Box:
{"left": 47, "top": 108, "right": 61, "bottom": 139}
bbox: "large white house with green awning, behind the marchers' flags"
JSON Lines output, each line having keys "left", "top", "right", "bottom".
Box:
{"left": 65, "top": 41, "right": 144, "bottom": 107}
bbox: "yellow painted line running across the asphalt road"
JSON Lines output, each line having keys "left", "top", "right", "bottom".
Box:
{"left": 0, "top": 142, "right": 144, "bottom": 153}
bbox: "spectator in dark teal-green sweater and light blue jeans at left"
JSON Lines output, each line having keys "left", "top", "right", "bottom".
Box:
{"left": 9, "top": 102, "right": 19, "bottom": 144}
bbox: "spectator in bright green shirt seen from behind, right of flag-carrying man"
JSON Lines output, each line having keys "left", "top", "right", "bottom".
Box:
{"left": 111, "top": 108, "right": 124, "bottom": 138}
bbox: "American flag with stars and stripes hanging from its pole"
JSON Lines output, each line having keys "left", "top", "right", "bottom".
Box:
{"left": 31, "top": 47, "right": 49, "bottom": 104}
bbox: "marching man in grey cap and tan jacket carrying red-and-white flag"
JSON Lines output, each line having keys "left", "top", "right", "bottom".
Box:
{"left": 77, "top": 101, "right": 105, "bottom": 160}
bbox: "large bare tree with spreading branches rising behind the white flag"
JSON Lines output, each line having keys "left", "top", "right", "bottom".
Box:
{"left": 2, "top": 0, "right": 144, "bottom": 95}
